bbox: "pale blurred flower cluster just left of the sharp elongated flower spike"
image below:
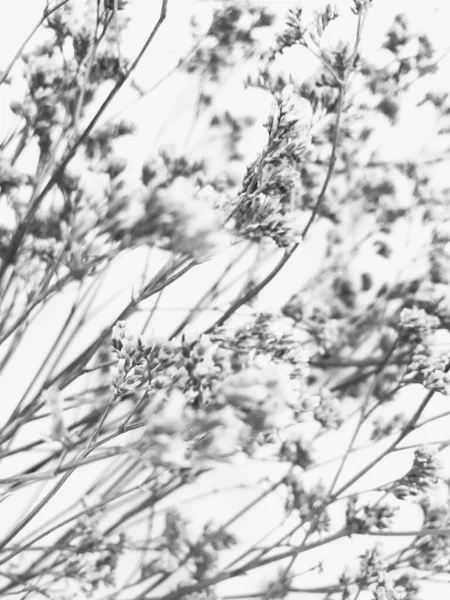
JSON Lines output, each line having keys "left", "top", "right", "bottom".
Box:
{"left": 107, "top": 151, "right": 231, "bottom": 262}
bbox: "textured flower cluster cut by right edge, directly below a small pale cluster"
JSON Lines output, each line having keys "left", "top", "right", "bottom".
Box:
{"left": 403, "top": 344, "right": 450, "bottom": 395}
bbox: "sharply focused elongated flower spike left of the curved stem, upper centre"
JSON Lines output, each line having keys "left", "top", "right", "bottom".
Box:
{"left": 234, "top": 89, "right": 310, "bottom": 247}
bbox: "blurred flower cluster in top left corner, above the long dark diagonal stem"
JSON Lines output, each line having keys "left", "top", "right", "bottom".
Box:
{"left": 14, "top": 5, "right": 128, "bottom": 160}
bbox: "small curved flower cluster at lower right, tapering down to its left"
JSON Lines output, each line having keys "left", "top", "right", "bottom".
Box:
{"left": 392, "top": 446, "right": 440, "bottom": 500}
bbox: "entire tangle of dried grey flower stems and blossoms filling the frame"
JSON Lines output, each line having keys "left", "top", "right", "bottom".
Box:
{"left": 0, "top": 0, "right": 450, "bottom": 600}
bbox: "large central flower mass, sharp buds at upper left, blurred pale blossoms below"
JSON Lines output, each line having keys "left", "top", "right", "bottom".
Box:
{"left": 108, "top": 315, "right": 312, "bottom": 467}
